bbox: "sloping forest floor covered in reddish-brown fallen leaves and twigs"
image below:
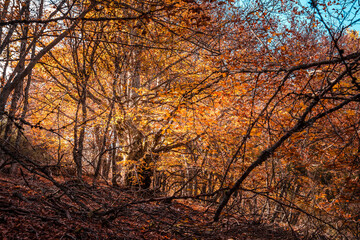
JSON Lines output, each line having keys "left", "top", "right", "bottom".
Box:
{"left": 0, "top": 170, "right": 300, "bottom": 240}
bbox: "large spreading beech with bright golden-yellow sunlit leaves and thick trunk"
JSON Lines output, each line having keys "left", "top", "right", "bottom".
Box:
{"left": 24, "top": 2, "right": 222, "bottom": 187}
